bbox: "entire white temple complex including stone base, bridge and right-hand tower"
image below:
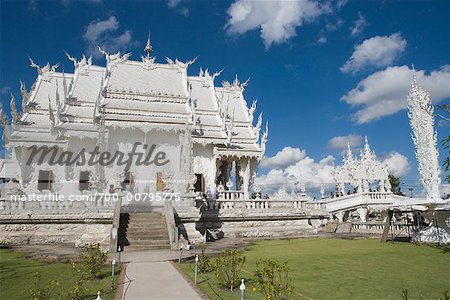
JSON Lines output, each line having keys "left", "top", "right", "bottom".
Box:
{"left": 0, "top": 40, "right": 450, "bottom": 251}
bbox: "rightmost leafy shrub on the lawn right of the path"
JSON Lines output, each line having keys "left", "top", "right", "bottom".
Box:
{"left": 253, "top": 259, "right": 294, "bottom": 300}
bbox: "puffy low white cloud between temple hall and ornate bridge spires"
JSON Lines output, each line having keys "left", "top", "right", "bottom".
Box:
{"left": 255, "top": 147, "right": 334, "bottom": 194}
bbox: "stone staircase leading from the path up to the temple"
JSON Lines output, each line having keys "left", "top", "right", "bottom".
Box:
{"left": 118, "top": 212, "right": 170, "bottom": 252}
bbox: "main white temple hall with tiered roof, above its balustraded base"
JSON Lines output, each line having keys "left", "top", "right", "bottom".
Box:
{"left": 3, "top": 40, "right": 267, "bottom": 202}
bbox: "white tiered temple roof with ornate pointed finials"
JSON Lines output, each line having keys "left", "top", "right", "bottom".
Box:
{"left": 4, "top": 38, "right": 264, "bottom": 158}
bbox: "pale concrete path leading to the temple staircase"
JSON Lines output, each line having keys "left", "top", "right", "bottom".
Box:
{"left": 122, "top": 261, "right": 202, "bottom": 300}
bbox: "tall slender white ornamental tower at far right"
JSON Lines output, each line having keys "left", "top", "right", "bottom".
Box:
{"left": 408, "top": 71, "right": 441, "bottom": 201}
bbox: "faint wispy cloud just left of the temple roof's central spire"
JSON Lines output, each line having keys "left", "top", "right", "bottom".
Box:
{"left": 83, "top": 16, "right": 139, "bottom": 58}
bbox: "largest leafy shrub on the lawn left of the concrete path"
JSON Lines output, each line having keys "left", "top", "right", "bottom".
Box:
{"left": 79, "top": 244, "right": 108, "bottom": 279}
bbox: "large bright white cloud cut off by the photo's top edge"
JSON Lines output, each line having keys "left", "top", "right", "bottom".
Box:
{"left": 225, "top": 0, "right": 333, "bottom": 49}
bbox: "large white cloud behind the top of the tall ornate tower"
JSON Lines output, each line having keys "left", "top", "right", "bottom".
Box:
{"left": 341, "top": 65, "right": 450, "bottom": 124}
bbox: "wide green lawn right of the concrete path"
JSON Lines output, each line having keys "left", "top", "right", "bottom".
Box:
{"left": 180, "top": 238, "right": 450, "bottom": 299}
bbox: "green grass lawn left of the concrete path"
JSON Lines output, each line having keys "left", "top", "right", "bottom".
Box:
{"left": 0, "top": 249, "right": 119, "bottom": 300}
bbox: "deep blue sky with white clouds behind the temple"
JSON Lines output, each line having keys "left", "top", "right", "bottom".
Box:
{"left": 0, "top": 0, "right": 450, "bottom": 195}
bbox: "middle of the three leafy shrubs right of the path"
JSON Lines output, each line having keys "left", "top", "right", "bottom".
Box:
{"left": 215, "top": 250, "right": 245, "bottom": 290}
